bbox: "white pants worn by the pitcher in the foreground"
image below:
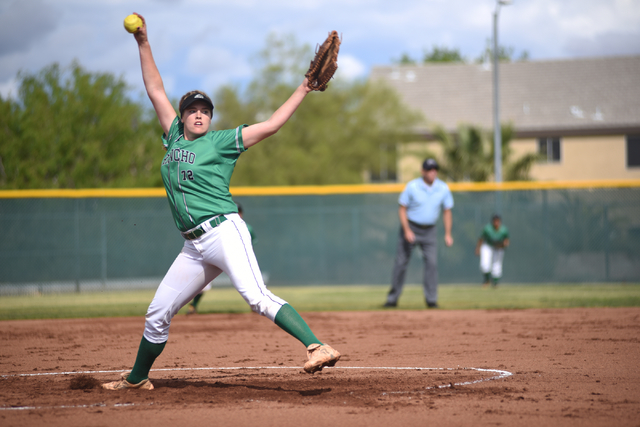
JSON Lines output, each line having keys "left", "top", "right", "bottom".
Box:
{"left": 144, "top": 214, "right": 286, "bottom": 344}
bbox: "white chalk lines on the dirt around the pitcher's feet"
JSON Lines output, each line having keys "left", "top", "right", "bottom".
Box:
{"left": 0, "top": 366, "right": 513, "bottom": 411}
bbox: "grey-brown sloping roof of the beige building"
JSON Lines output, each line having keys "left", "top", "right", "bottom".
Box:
{"left": 370, "top": 56, "right": 640, "bottom": 136}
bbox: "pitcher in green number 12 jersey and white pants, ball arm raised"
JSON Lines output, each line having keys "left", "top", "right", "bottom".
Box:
{"left": 102, "top": 14, "right": 340, "bottom": 390}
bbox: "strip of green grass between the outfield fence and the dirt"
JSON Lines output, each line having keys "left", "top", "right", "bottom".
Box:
{"left": 0, "top": 284, "right": 640, "bottom": 320}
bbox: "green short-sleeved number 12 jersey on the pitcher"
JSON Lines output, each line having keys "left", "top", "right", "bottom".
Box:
{"left": 161, "top": 117, "right": 245, "bottom": 232}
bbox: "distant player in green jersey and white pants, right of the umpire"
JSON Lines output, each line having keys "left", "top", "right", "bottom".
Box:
{"left": 476, "top": 214, "right": 509, "bottom": 287}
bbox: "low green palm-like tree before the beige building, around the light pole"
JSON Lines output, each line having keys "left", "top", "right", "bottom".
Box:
{"left": 434, "top": 125, "right": 539, "bottom": 182}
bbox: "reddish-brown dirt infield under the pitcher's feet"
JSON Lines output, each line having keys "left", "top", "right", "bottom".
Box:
{"left": 0, "top": 308, "right": 640, "bottom": 427}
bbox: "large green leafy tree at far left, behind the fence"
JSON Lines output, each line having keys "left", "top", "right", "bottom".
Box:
{"left": 0, "top": 63, "right": 163, "bottom": 188}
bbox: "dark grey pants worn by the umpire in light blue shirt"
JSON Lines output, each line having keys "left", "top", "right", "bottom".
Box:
{"left": 387, "top": 222, "right": 438, "bottom": 304}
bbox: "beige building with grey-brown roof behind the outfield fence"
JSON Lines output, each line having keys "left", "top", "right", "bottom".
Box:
{"left": 370, "top": 56, "right": 640, "bottom": 182}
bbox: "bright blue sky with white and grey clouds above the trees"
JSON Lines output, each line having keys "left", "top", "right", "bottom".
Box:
{"left": 0, "top": 0, "right": 640, "bottom": 98}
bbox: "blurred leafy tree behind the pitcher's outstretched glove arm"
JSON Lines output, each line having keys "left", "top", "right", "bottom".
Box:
{"left": 214, "top": 34, "right": 421, "bottom": 185}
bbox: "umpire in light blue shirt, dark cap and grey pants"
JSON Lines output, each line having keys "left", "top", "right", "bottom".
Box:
{"left": 384, "top": 159, "right": 453, "bottom": 308}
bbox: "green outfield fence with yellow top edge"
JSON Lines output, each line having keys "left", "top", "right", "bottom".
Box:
{"left": 0, "top": 180, "right": 640, "bottom": 295}
